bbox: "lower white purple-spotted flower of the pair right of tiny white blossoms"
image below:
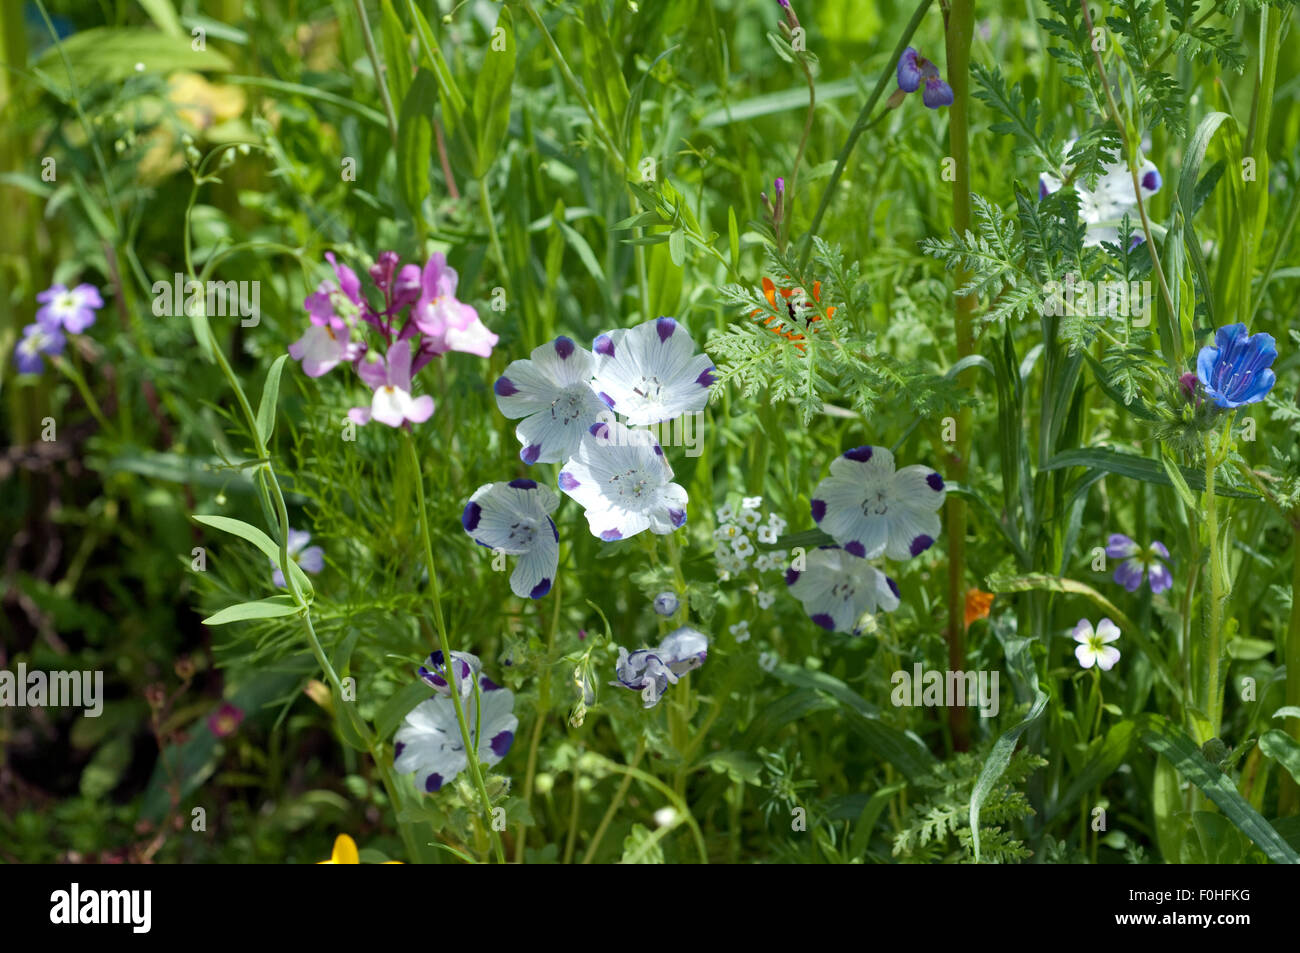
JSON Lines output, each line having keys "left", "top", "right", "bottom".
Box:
{"left": 785, "top": 546, "right": 898, "bottom": 636}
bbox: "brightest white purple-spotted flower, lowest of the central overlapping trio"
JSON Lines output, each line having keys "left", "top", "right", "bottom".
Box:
{"left": 559, "top": 423, "right": 688, "bottom": 541}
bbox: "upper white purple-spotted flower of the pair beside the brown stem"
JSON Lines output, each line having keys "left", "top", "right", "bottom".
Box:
{"left": 813, "top": 447, "right": 945, "bottom": 559}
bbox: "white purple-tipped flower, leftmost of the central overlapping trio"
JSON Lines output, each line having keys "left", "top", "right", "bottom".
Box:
{"left": 493, "top": 337, "right": 608, "bottom": 464}
